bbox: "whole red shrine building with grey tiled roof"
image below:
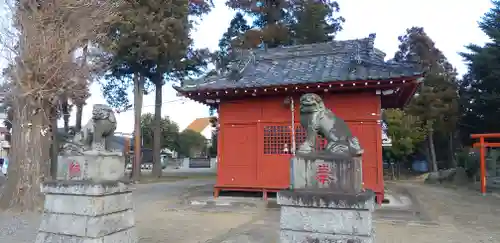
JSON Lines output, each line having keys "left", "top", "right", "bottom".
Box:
{"left": 175, "top": 34, "right": 422, "bottom": 203}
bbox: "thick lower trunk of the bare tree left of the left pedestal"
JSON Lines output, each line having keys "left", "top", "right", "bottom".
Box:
{"left": 0, "top": 98, "right": 50, "bottom": 211}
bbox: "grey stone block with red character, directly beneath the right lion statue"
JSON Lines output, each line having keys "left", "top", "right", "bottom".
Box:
{"left": 290, "top": 152, "right": 363, "bottom": 193}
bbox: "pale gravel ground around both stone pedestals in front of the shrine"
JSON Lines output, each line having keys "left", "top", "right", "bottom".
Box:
{"left": 0, "top": 180, "right": 500, "bottom": 243}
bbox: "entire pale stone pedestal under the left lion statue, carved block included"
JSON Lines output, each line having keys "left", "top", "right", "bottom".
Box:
{"left": 36, "top": 151, "right": 138, "bottom": 243}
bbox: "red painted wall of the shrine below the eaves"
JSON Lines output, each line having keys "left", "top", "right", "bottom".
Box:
{"left": 216, "top": 92, "right": 383, "bottom": 196}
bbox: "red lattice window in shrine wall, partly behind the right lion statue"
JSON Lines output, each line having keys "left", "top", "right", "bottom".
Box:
{"left": 264, "top": 125, "right": 326, "bottom": 154}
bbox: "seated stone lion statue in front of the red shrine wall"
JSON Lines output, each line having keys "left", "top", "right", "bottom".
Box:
{"left": 299, "top": 93, "right": 364, "bottom": 156}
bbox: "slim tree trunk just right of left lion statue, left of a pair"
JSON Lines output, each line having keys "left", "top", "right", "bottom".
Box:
{"left": 132, "top": 74, "right": 144, "bottom": 181}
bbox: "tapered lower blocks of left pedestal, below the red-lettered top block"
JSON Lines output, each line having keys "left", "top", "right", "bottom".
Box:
{"left": 35, "top": 180, "right": 138, "bottom": 243}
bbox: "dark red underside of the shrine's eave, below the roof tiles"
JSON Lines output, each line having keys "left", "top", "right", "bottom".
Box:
{"left": 174, "top": 74, "right": 422, "bottom": 108}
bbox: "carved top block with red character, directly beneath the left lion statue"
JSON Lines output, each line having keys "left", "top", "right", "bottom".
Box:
{"left": 57, "top": 150, "right": 125, "bottom": 181}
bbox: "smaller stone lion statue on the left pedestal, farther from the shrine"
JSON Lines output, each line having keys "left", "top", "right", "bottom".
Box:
{"left": 77, "top": 104, "right": 116, "bottom": 151}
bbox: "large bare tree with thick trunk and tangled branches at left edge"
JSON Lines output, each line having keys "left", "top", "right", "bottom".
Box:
{"left": 0, "top": 0, "right": 120, "bottom": 210}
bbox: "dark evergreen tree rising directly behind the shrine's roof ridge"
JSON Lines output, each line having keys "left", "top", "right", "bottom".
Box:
{"left": 227, "top": 0, "right": 344, "bottom": 48}
